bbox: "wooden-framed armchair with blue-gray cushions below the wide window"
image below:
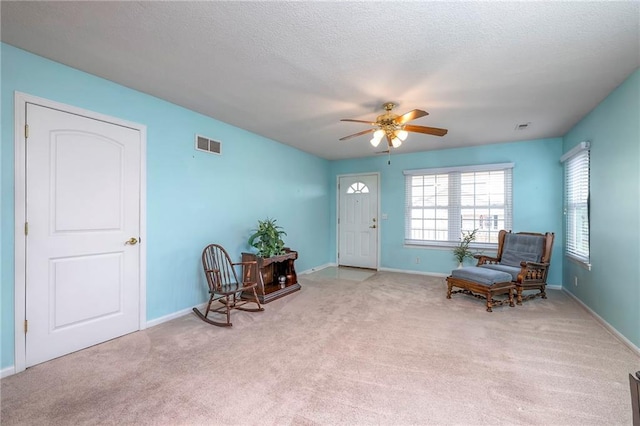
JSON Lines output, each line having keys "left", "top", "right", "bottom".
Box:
{"left": 474, "top": 230, "right": 554, "bottom": 305}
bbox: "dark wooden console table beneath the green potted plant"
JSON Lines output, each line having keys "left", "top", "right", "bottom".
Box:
{"left": 242, "top": 248, "right": 300, "bottom": 303}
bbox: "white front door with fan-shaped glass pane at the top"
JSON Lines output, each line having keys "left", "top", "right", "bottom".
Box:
{"left": 338, "top": 174, "right": 379, "bottom": 268}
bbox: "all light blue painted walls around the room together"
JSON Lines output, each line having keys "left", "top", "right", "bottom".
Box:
{"left": 0, "top": 44, "right": 640, "bottom": 368}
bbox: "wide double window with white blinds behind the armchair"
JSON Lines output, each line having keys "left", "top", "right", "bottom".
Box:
{"left": 404, "top": 163, "right": 513, "bottom": 248}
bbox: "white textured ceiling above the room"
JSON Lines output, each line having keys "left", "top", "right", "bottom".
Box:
{"left": 1, "top": 1, "right": 640, "bottom": 159}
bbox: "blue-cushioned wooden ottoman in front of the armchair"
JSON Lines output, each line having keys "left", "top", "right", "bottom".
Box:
{"left": 447, "top": 266, "right": 516, "bottom": 312}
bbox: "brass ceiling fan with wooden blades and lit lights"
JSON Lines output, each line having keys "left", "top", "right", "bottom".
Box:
{"left": 340, "top": 102, "right": 448, "bottom": 150}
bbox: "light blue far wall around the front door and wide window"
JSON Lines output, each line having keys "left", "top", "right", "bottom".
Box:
{"left": 330, "top": 139, "right": 563, "bottom": 285}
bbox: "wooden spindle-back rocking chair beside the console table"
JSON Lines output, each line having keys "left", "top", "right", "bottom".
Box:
{"left": 193, "top": 244, "right": 264, "bottom": 327}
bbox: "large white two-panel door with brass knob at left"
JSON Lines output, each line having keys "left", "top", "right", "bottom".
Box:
{"left": 25, "top": 103, "right": 142, "bottom": 367}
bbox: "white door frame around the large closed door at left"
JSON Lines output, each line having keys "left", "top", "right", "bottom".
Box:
{"left": 14, "top": 92, "right": 147, "bottom": 373}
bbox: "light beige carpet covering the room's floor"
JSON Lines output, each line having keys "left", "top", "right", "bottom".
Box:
{"left": 0, "top": 272, "right": 640, "bottom": 425}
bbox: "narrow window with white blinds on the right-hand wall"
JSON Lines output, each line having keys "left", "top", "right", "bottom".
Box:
{"left": 561, "top": 142, "right": 590, "bottom": 265}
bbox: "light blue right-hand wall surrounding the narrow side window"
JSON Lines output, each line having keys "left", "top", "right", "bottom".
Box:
{"left": 564, "top": 70, "right": 640, "bottom": 347}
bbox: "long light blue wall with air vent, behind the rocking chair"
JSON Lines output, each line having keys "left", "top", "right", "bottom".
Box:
{"left": 0, "top": 44, "right": 329, "bottom": 368}
